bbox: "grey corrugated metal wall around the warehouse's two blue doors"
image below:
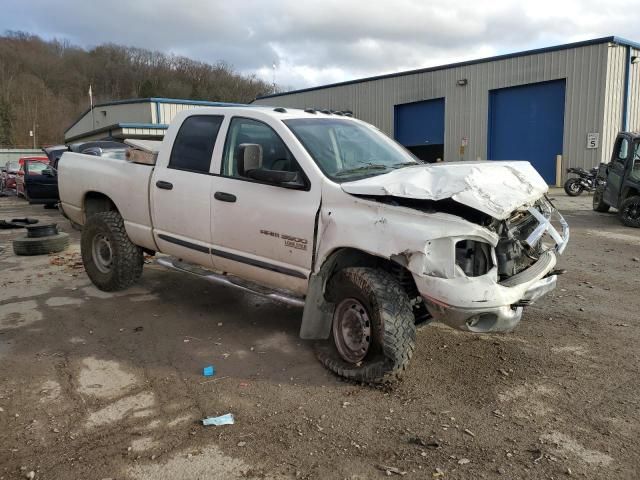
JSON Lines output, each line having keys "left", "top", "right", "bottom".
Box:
{"left": 254, "top": 43, "right": 612, "bottom": 175}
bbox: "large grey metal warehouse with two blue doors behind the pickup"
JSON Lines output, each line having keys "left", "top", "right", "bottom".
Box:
{"left": 254, "top": 37, "right": 640, "bottom": 184}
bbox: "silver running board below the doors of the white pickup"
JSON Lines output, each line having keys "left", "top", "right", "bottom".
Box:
{"left": 156, "top": 257, "right": 304, "bottom": 307}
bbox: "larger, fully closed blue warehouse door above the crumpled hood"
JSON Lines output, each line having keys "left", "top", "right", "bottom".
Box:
{"left": 487, "top": 80, "right": 565, "bottom": 184}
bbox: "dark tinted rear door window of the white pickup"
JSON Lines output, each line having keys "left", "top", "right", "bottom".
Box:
{"left": 169, "top": 115, "right": 224, "bottom": 173}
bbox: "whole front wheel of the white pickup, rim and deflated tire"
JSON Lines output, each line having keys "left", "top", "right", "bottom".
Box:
{"left": 316, "top": 267, "right": 416, "bottom": 383}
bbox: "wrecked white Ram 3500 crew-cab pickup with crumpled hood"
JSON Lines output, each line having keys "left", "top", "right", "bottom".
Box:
{"left": 59, "top": 106, "right": 569, "bottom": 382}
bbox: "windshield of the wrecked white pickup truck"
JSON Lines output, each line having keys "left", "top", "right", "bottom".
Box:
{"left": 284, "top": 118, "right": 421, "bottom": 182}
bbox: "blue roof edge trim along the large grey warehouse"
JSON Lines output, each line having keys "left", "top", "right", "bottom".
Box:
{"left": 253, "top": 36, "right": 624, "bottom": 101}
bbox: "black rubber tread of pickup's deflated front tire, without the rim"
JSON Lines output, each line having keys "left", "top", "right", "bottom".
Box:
{"left": 316, "top": 267, "right": 416, "bottom": 384}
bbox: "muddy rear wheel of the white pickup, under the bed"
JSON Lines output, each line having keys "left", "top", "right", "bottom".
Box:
{"left": 80, "top": 212, "right": 144, "bottom": 292}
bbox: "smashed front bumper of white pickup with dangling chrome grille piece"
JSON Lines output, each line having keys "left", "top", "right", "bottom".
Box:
{"left": 414, "top": 206, "right": 569, "bottom": 333}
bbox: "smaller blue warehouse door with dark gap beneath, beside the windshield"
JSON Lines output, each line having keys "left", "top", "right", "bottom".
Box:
{"left": 394, "top": 98, "right": 444, "bottom": 161}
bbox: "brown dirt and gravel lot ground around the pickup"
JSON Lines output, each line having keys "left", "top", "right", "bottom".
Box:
{"left": 0, "top": 189, "right": 640, "bottom": 480}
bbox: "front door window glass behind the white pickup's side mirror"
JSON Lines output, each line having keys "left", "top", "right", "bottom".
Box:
{"left": 222, "top": 117, "right": 304, "bottom": 186}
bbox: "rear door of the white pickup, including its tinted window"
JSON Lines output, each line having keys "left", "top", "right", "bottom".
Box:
{"left": 150, "top": 115, "right": 224, "bottom": 266}
